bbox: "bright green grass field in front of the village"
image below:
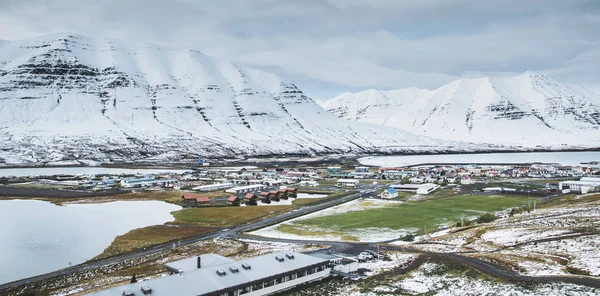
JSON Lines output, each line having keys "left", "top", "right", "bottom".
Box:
{"left": 280, "top": 195, "right": 527, "bottom": 233}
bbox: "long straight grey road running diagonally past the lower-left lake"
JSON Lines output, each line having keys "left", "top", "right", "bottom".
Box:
{"left": 0, "top": 185, "right": 383, "bottom": 295}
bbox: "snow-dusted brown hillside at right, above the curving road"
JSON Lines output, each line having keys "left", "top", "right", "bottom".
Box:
{"left": 413, "top": 197, "right": 600, "bottom": 276}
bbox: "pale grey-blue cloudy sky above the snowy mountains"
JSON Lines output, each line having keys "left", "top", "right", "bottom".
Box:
{"left": 0, "top": 0, "right": 600, "bottom": 99}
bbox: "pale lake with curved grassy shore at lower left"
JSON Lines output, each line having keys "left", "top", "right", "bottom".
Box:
{"left": 0, "top": 200, "right": 181, "bottom": 284}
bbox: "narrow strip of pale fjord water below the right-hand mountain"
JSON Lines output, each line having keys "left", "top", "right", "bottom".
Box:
{"left": 358, "top": 151, "right": 600, "bottom": 166}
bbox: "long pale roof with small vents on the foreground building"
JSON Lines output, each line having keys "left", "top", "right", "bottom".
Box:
{"left": 88, "top": 252, "right": 328, "bottom": 296}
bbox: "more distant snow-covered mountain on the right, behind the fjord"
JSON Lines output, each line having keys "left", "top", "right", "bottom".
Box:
{"left": 320, "top": 72, "right": 600, "bottom": 149}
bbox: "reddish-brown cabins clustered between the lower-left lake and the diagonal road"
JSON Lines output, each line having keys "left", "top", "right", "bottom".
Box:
{"left": 181, "top": 187, "right": 298, "bottom": 206}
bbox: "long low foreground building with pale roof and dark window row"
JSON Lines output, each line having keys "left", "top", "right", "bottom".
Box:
{"left": 88, "top": 252, "right": 331, "bottom": 296}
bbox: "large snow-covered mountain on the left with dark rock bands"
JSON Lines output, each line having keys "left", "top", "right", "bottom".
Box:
{"left": 0, "top": 34, "right": 475, "bottom": 165}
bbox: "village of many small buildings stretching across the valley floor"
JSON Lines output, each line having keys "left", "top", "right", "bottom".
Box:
{"left": 0, "top": 162, "right": 600, "bottom": 206}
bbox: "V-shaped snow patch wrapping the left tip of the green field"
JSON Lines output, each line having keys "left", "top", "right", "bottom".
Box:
{"left": 251, "top": 199, "right": 414, "bottom": 242}
